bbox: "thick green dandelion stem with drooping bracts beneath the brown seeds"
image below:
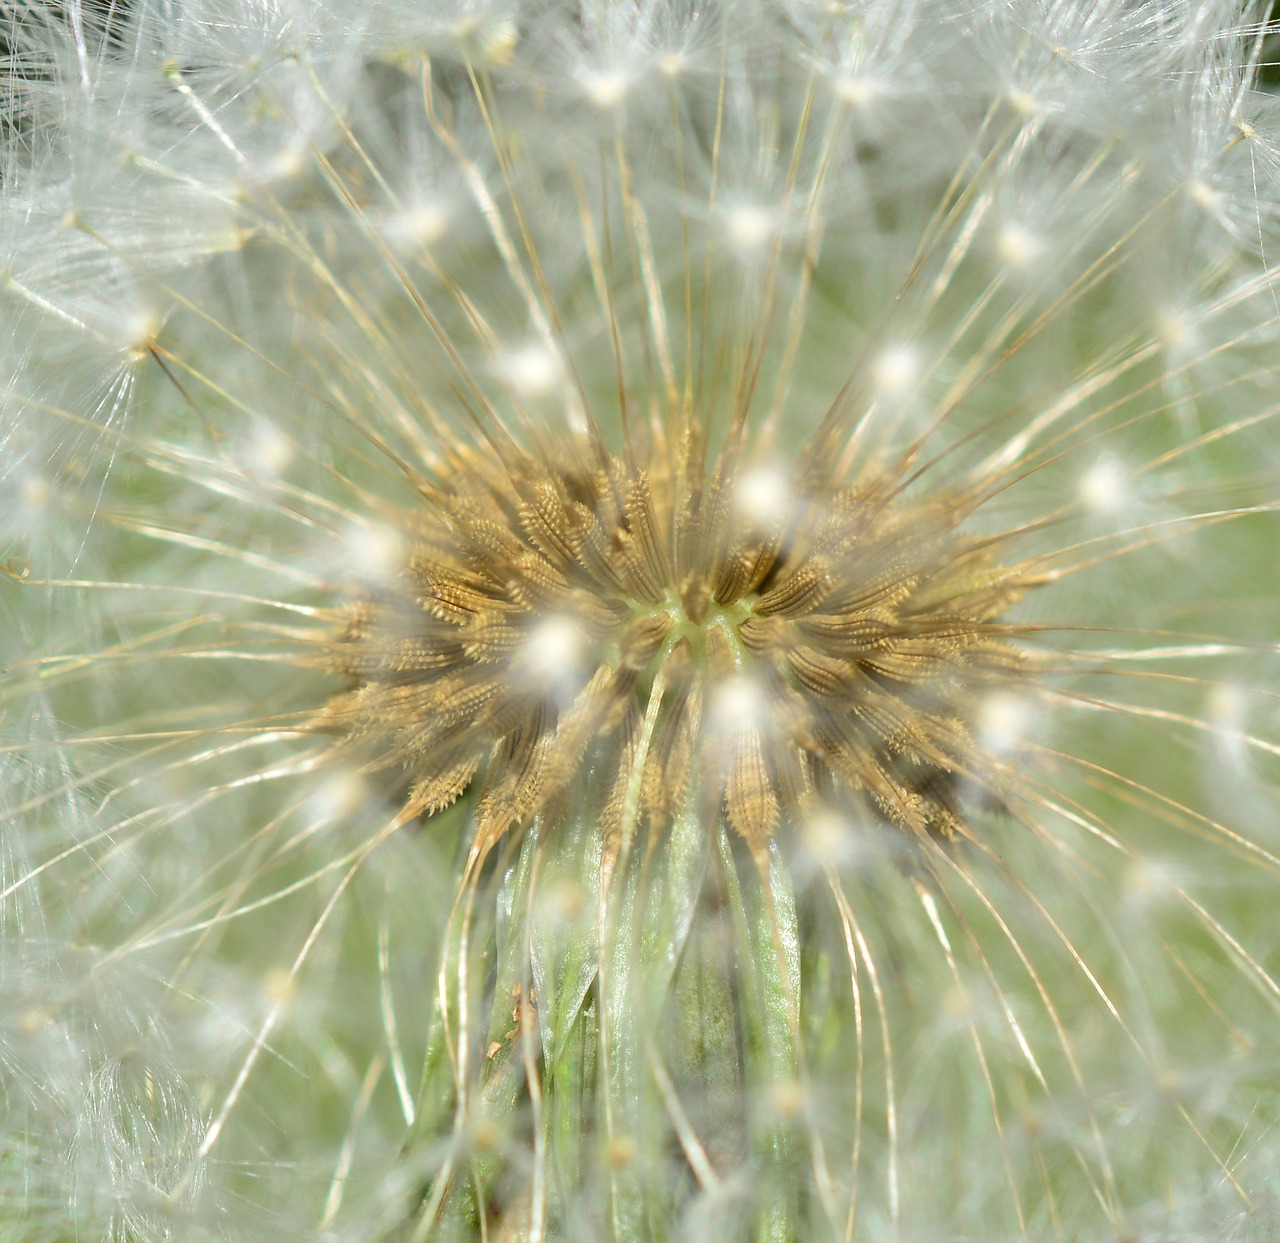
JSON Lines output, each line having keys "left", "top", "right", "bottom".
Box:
{"left": 404, "top": 793, "right": 819, "bottom": 1243}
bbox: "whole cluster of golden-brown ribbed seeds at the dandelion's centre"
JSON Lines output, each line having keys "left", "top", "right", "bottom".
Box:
{"left": 323, "top": 440, "right": 1023, "bottom": 865}
